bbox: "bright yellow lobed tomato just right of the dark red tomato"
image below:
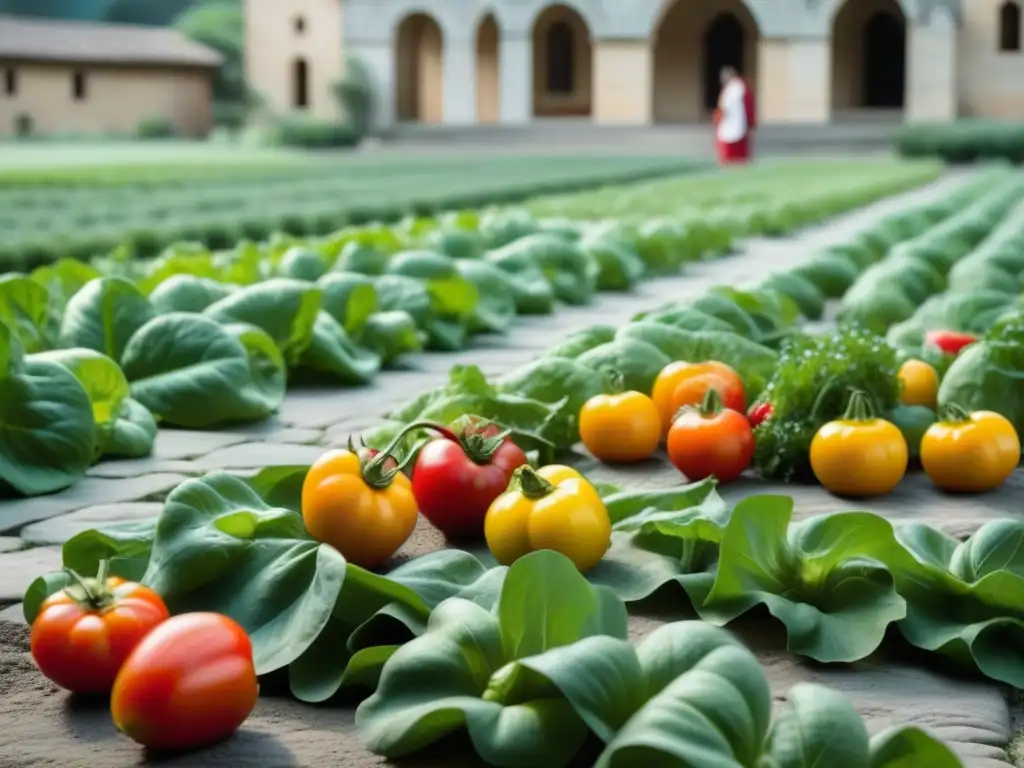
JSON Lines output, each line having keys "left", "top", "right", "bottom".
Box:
{"left": 483, "top": 464, "right": 611, "bottom": 571}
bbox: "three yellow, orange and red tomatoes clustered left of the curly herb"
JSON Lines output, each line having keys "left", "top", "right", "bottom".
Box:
{"left": 580, "top": 360, "right": 757, "bottom": 482}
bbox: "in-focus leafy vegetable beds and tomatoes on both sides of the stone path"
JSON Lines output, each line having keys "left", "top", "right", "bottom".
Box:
{"left": 0, "top": 156, "right": 1024, "bottom": 768}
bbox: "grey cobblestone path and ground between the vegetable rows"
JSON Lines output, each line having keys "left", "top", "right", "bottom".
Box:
{"left": 0, "top": 171, "right": 1024, "bottom": 768}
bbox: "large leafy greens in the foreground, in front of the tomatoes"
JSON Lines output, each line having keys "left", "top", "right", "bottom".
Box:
{"left": 25, "top": 467, "right": 966, "bottom": 768}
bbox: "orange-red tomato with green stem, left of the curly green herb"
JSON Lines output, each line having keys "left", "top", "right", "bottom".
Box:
{"left": 667, "top": 389, "right": 754, "bottom": 482}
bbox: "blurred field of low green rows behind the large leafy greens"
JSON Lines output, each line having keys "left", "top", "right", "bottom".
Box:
{"left": 0, "top": 155, "right": 697, "bottom": 270}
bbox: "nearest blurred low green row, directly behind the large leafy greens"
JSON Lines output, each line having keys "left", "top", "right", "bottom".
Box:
{"left": 0, "top": 157, "right": 696, "bottom": 270}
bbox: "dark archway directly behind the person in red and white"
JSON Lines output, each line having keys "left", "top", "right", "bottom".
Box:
{"left": 651, "top": 0, "right": 761, "bottom": 123}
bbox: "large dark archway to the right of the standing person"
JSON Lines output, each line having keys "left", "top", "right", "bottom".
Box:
{"left": 831, "top": 0, "right": 907, "bottom": 114}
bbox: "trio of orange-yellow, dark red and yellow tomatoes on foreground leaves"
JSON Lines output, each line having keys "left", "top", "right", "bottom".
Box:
{"left": 302, "top": 414, "right": 610, "bottom": 570}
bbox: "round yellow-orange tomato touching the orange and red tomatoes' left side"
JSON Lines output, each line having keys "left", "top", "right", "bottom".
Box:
{"left": 580, "top": 391, "right": 662, "bottom": 463}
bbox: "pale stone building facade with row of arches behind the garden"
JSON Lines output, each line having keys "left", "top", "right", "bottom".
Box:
{"left": 246, "top": 0, "right": 1024, "bottom": 126}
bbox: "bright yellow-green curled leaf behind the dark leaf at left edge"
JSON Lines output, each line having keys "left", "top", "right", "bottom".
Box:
{"left": 30, "top": 348, "right": 157, "bottom": 459}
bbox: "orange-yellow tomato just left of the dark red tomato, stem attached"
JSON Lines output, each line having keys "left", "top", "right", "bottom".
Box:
{"left": 302, "top": 450, "right": 419, "bottom": 568}
